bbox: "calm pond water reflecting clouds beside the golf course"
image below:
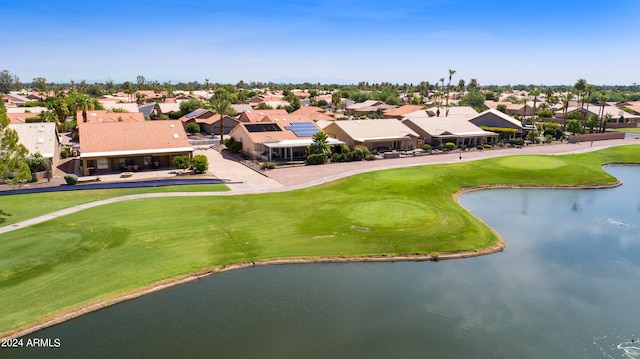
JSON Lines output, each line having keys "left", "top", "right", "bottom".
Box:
{"left": 6, "top": 167, "right": 640, "bottom": 358}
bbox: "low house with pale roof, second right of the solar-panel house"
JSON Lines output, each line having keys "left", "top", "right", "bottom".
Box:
{"left": 402, "top": 110, "right": 498, "bottom": 147}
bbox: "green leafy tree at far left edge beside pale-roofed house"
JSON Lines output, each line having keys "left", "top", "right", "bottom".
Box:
{"left": 0, "top": 93, "right": 31, "bottom": 185}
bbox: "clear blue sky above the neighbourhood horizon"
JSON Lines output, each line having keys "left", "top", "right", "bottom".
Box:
{"left": 5, "top": 0, "right": 640, "bottom": 85}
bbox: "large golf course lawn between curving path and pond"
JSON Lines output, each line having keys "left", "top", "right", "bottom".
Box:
{"left": 0, "top": 146, "right": 640, "bottom": 332}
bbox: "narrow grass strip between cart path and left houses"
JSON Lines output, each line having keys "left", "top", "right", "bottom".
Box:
{"left": 0, "top": 184, "right": 229, "bottom": 227}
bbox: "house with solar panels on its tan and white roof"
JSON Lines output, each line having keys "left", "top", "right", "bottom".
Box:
{"left": 229, "top": 119, "right": 344, "bottom": 161}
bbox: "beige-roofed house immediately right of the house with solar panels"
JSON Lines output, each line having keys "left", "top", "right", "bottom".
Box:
{"left": 323, "top": 118, "right": 421, "bottom": 151}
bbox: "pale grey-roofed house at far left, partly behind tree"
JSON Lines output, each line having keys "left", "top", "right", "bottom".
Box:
{"left": 9, "top": 122, "right": 60, "bottom": 178}
